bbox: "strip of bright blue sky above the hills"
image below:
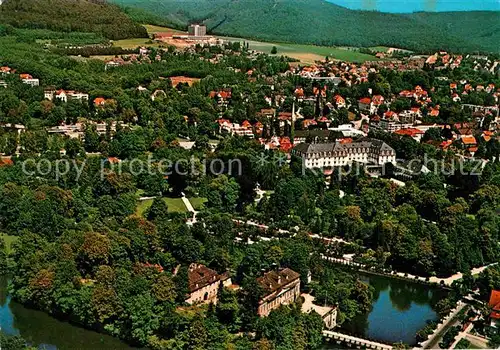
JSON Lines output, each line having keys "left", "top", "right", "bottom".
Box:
{"left": 327, "top": 0, "right": 500, "bottom": 12}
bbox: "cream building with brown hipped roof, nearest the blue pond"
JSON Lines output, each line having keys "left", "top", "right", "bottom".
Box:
{"left": 257, "top": 268, "right": 300, "bottom": 317}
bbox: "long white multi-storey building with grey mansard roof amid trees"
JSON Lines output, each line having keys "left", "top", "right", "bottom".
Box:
{"left": 292, "top": 139, "right": 396, "bottom": 169}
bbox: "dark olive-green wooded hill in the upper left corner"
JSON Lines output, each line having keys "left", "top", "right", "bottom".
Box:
{"left": 0, "top": 0, "right": 147, "bottom": 40}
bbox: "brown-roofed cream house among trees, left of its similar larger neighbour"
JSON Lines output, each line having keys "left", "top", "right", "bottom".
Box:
{"left": 186, "top": 263, "right": 231, "bottom": 304}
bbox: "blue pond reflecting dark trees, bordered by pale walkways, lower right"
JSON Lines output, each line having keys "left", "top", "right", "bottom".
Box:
{"left": 341, "top": 275, "right": 446, "bottom": 345}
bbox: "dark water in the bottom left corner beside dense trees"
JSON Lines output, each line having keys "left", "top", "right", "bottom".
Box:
{"left": 0, "top": 276, "right": 133, "bottom": 350}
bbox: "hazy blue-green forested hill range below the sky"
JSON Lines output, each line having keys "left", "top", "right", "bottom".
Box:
{"left": 112, "top": 0, "right": 500, "bottom": 52}
